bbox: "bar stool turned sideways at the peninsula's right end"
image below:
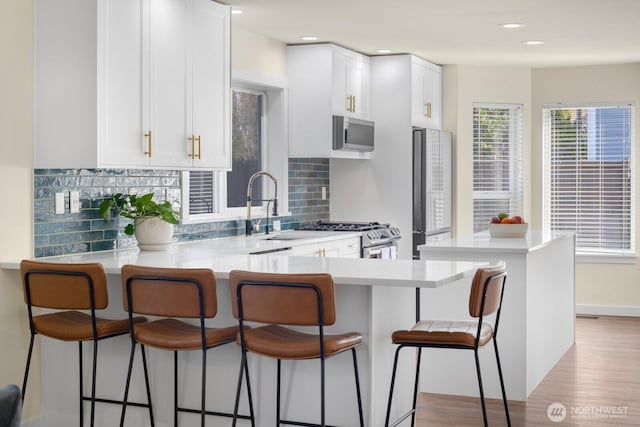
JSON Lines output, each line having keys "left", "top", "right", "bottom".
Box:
{"left": 385, "top": 262, "right": 511, "bottom": 427}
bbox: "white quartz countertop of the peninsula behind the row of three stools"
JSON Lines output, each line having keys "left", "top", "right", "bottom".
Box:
{"left": 0, "top": 231, "right": 482, "bottom": 287}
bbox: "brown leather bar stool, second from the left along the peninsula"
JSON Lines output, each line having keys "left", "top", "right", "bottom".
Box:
{"left": 120, "top": 265, "right": 253, "bottom": 427}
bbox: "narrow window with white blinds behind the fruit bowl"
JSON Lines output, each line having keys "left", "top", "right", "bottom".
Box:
{"left": 473, "top": 104, "right": 524, "bottom": 232}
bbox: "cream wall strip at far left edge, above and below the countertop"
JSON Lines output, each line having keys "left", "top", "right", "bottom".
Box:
{"left": 0, "top": 0, "right": 40, "bottom": 419}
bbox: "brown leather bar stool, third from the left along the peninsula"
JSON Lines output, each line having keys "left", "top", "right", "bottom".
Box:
{"left": 229, "top": 270, "right": 364, "bottom": 427}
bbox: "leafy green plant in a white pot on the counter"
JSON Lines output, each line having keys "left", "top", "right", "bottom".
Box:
{"left": 100, "top": 193, "right": 180, "bottom": 251}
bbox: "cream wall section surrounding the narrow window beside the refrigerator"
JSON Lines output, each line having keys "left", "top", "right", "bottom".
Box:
{"left": 442, "top": 65, "right": 535, "bottom": 236}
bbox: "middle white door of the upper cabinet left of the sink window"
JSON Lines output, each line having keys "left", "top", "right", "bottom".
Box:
{"left": 143, "top": 0, "right": 192, "bottom": 167}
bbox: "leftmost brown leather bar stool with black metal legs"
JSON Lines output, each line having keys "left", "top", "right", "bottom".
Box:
{"left": 20, "top": 260, "right": 151, "bottom": 426}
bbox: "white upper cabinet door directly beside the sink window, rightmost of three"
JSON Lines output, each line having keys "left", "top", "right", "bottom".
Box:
{"left": 188, "top": 0, "right": 231, "bottom": 169}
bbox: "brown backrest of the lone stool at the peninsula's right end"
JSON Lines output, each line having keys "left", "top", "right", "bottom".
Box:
{"left": 469, "top": 262, "right": 507, "bottom": 317}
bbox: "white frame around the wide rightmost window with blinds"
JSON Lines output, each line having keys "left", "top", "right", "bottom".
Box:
{"left": 541, "top": 102, "right": 638, "bottom": 264}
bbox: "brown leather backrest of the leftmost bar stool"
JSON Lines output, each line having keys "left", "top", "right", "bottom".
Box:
{"left": 20, "top": 260, "right": 109, "bottom": 310}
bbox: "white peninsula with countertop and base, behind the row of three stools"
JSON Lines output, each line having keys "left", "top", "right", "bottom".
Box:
{"left": 1, "top": 231, "right": 481, "bottom": 427}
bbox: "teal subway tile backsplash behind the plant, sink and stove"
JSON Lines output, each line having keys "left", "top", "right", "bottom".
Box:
{"left": 34, "top": 158, "right": 329, "bottom": 257}
